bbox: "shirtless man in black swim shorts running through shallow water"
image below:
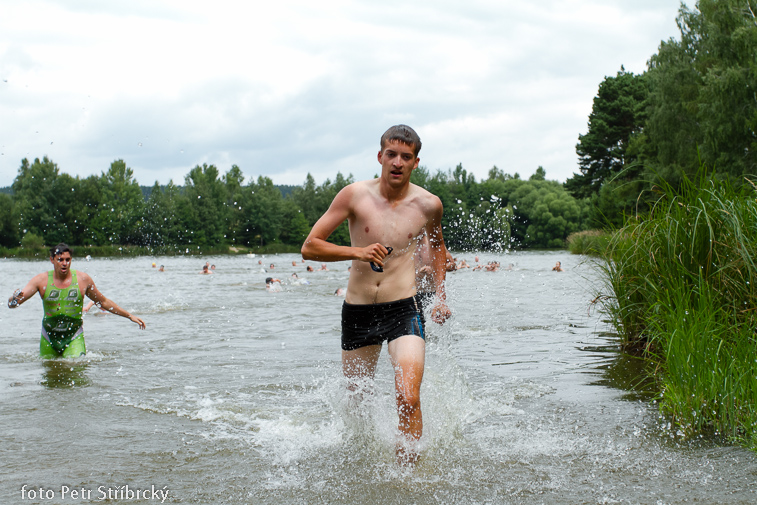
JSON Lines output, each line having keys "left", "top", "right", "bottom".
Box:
{"left": 302, "top": 125, "right": 451, "bottom": 463}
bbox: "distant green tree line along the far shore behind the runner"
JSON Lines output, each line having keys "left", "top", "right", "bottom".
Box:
{"left": 0, "top": 157, "right": 587, "bottom": 254}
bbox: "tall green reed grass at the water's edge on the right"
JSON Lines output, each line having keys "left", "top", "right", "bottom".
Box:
{"left": 603, "top": 172, "right": 757, "bottom": 448}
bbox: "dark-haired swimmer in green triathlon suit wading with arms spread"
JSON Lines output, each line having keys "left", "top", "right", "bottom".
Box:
{"left": 8, "top": 243, "right": 145, "bottom": 358}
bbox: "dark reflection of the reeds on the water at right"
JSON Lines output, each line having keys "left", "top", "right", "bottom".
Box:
{"left": 579, "top": 333, "right": 659, "bottom": 402}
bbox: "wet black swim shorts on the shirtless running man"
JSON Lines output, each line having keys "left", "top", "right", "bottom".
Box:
{"left": 342, "top": 296, "right": 426, "bottom": 351}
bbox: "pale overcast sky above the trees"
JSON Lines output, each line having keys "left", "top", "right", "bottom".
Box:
{"left": 0, "top": 0, "right": 680, "bottom": 187}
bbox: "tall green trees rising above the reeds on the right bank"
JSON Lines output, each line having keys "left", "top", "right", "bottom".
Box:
{"left": 565, "top": 0, "right": 757, "bottom": 226}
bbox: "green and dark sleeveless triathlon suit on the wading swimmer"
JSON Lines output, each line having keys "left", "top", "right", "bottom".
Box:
{"left": 39, "top": 270, "right": 87, "bottom": 358}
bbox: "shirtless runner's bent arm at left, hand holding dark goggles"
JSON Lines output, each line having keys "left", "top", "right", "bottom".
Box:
{"left": 301, "top": 184, "right": 389, "bottom": 267}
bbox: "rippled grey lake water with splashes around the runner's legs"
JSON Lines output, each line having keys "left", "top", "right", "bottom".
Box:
{"left": 0, "top": 252, "right": 757, "bottom": 505}
